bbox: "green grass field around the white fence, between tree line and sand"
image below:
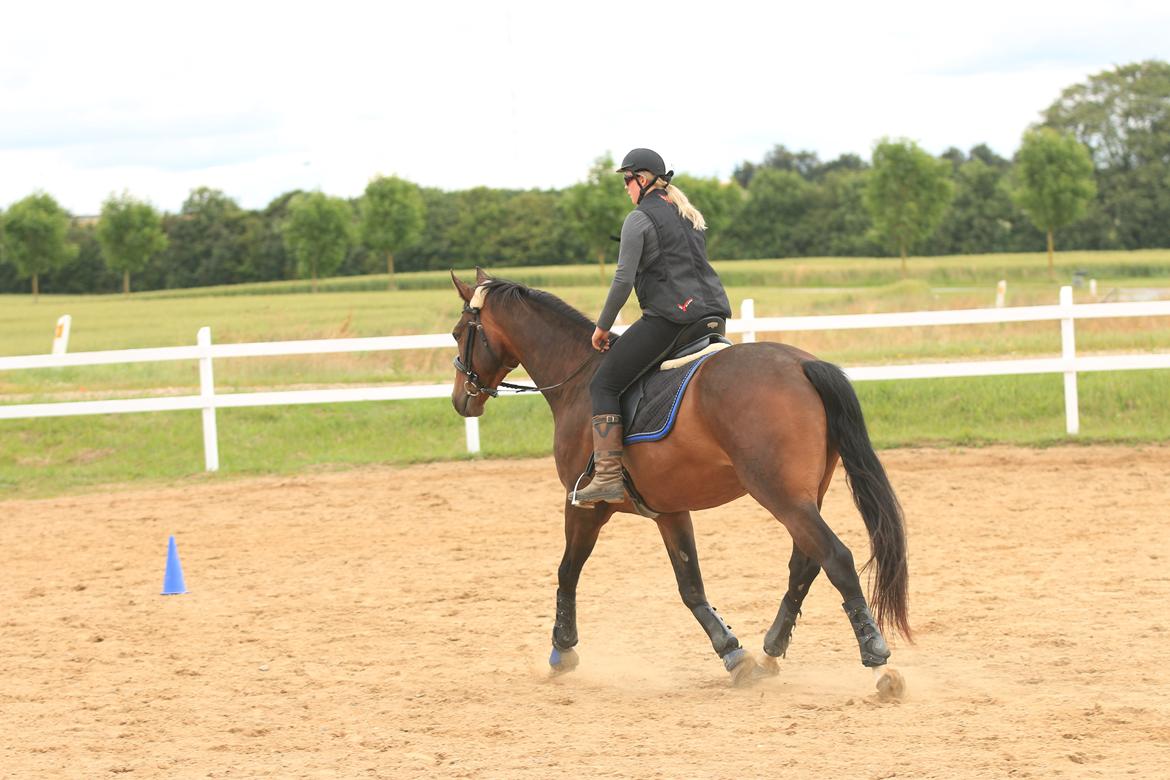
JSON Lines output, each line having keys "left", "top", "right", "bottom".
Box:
{"left": 0, "top": 251, "right": 1170, "bottom": 496}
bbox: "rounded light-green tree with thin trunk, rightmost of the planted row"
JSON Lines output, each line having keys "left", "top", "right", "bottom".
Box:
{"left": 1013, "top": 127, "right": 1096, "bottom": 277}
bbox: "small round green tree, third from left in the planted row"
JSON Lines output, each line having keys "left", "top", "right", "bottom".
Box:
{"left": 284, "top": 192, "right": 353, "bottom": 292}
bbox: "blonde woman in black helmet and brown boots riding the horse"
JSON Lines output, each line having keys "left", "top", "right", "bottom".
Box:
{"left": 573, "top": 149, "right": 731, "bottom": 506}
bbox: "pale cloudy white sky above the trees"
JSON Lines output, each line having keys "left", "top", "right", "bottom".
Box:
{"left": 0, "top": 0, "right": 1170, "bottom": 215}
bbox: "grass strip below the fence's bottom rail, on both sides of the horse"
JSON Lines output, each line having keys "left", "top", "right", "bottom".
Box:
{"left": 0, "top": 371, "right": 1170, "bottom": 497}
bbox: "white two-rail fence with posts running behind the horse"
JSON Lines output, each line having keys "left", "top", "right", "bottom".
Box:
{"left": 0, "top": 287, "right": 1170, "bottom": 471}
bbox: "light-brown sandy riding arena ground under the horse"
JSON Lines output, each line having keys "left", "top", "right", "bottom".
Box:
{"left": 0, "top": 447, "right": 1170, "bottom": 778}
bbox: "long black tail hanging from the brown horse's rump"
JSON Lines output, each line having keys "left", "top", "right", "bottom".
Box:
{"left": 801, "top": 360, "right": 913, "bottom": 641}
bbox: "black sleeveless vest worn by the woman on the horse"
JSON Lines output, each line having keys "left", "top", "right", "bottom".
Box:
{"left": 634, "top": 189, "right": 731, "bottom": 323}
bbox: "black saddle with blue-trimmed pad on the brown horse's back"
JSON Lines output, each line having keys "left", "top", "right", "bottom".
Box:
{"left": 621, "top": 317, "right": 731, "bottom": 444}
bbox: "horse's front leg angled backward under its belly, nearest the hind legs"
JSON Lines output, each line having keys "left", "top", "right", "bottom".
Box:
{"left": 656, "top": 512, "right": 756, "bottom": 684}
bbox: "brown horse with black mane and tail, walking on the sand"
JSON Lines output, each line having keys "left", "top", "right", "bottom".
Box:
{"left": 450, "top": 268, "right": 913, "bottom": 698}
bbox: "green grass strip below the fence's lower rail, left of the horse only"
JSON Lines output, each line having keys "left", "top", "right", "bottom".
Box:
{"left": 0, "top": 398, "right": 552, "bottom": 497}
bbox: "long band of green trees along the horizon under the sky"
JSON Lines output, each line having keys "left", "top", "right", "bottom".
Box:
{"left": 0, "top": 61, "right": 1170, "bottom": 295}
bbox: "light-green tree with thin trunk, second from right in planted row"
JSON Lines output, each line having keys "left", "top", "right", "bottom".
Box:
{"left": 866, "top": 138, "right": 955, "bottom": 276}
